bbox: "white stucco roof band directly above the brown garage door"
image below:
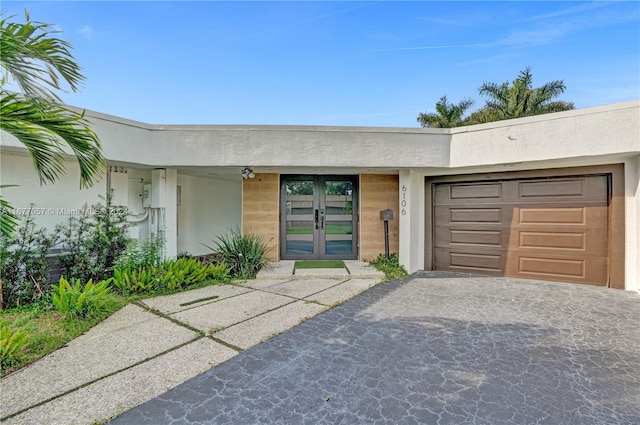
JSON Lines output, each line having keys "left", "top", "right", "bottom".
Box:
{"left": 449, "top": 102, "right": 640, "bottom": 167}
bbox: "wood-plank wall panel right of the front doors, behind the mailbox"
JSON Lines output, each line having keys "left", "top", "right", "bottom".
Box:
{"left": 359, "top": 174, "right": 399, "bottom": 261}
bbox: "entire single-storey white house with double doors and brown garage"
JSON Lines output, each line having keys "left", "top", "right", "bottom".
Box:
{"left": 0, "top": 101, "right": 640, "bottom": 290}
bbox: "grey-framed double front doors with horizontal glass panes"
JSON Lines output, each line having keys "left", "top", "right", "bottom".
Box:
{"left": 280, "top": 175, "right": 358, "bottom": 260}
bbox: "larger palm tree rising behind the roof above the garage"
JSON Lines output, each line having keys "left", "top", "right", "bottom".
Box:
{"left": 470, "top": 67, "right": 574, "bottom": 122}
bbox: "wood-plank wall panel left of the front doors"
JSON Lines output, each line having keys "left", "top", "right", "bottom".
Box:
{"left": 242, "top": 173, "right": 280, "bottom": 261}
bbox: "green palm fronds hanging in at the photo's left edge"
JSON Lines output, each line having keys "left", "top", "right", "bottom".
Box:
{"left": 0, "top": 13, "right": 104, "bottom": 235}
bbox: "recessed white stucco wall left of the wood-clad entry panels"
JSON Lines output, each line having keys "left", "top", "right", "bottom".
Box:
{"left": 178, "top": 175, "right": 242, "bottom": 255}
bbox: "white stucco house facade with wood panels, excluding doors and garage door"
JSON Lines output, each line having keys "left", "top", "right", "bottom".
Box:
{"left": 0, "top": 101, "right": 640, "bottom": 290}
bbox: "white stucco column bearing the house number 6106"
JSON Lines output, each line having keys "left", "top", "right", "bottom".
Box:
{"left": 398, "top": 169, "right": 425, "bottom": 273}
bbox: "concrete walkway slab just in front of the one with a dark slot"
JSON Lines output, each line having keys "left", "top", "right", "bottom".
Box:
{"left": 172, "top": 291, "right": 292, "bottom": 333}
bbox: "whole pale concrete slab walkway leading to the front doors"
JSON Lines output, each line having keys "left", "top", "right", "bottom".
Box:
{"left": 0, "top": 261, "right": 383, "bottom": 425}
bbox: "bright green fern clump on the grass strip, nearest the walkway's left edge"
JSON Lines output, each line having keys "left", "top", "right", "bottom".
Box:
{"left": 52, "top": 277, "right": 113, "bottom": 317}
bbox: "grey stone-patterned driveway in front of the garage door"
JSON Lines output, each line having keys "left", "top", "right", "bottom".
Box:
{"left": 111, "top": 273, "right": 640, "bottom": 425}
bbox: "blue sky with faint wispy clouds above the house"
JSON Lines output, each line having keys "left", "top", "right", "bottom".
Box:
{"left": 2, "top": 0, "right": 640, "bottom": 127}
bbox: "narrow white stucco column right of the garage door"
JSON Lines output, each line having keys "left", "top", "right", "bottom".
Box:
{"left": 624, "top": 156, "right": 640, "bottom": 291}
